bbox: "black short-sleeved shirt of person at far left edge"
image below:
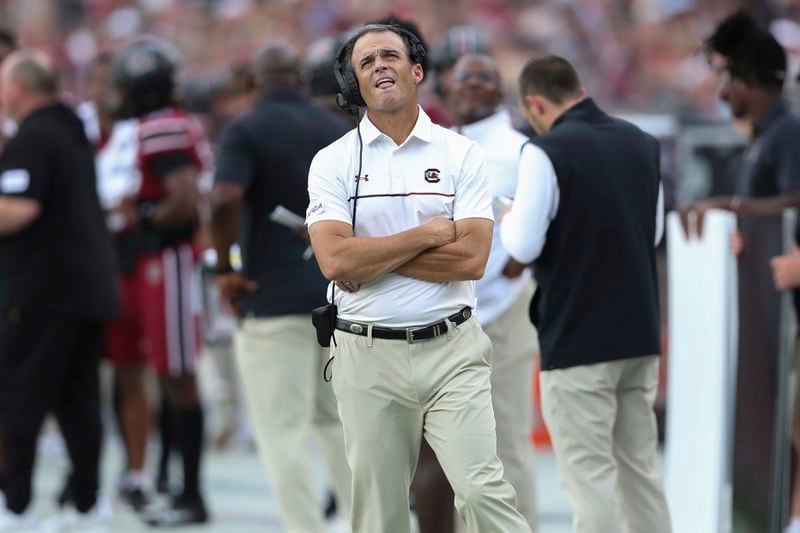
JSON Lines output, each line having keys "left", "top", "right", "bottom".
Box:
{"left": 0, "top": 103, "right": 119, "bottom": 320}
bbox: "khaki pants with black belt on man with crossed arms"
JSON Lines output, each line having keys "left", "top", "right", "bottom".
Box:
{"left": 333, "top": 318, "right": 530, "bottom": 533}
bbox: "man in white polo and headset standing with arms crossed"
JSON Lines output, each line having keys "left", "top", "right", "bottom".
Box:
{"left": 307, "top": 25, "right": 530, "bottom": 533}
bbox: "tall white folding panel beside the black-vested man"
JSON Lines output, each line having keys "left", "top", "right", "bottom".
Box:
{"left": 664, "top": 211, "right": 737, "bottom": 533}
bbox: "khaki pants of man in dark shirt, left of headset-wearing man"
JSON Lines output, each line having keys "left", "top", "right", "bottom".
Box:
{"left": 235, "top": 315, "right": 350, "bottom": 533}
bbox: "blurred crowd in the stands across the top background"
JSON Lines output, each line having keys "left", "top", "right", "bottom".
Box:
{"left": 0, "top": 0, "right": 800, "bottom": 129}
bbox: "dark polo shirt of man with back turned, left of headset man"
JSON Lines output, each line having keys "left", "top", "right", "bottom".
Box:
{"left": 215, "top": 88, "right": 353, "bottom": 317}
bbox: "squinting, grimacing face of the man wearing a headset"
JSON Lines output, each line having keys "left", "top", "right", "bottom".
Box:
{"left": 351, "top": 31, "right": 423, "bottom": 113}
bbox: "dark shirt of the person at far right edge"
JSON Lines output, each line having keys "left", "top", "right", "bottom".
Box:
{"left": 737, "top": 101, "right": 800, "bottom": 198}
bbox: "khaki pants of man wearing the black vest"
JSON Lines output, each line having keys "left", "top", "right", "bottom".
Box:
{"left": 541, "top": 356, "right": 670, "bottom": 533}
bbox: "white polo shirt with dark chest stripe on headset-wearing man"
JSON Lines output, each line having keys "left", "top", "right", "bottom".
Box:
{"left": 306, "top": 108, "right": 494, "bottom": 327}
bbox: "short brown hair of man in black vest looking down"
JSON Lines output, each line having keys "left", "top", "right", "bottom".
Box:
{"left": 519, "top": 55, "right": 581, "bottom": 105}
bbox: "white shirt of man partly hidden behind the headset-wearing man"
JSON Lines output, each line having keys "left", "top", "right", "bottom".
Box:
{"left": 460, "top": 109, "right": 531, "bottom": 326}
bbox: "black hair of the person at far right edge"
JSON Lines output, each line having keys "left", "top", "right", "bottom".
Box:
{"left": 704, "top": 11, "right": 786, "bottom": 89}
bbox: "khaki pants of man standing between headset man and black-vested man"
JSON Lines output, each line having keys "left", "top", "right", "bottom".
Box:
{"left": 484, "top": 284, "right": 539, "bottom": 531}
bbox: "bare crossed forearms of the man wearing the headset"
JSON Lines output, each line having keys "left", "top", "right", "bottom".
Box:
{"left": 309, "top": 217, "right": 493, "bottom": 284}
